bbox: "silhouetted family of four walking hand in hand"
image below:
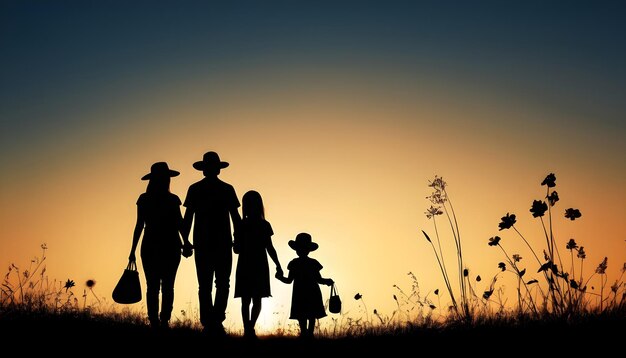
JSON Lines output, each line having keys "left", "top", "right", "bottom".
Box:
{"left": 128, "top": 151, "right": 334, "bottom": 338}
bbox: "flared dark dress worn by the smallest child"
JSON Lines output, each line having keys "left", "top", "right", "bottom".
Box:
{"left": 287, "top": 257, "right": 326, "bottom": 319}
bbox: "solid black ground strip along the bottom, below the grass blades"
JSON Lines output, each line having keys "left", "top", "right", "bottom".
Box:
{"left": 0, "top": 311, "right": 626, "bottom": 357}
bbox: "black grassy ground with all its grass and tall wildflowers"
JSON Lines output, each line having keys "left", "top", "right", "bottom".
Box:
{"left": 0, "top": 174, "right": 626, "bottom": 357}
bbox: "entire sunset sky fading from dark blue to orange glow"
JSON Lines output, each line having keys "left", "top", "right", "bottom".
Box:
{"left": 0, "top": 0, "right": 626, "bottom": 329}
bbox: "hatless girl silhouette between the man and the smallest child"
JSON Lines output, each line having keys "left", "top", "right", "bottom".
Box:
{"left": 233, "top": 190, "right": 283, "bottom": 338}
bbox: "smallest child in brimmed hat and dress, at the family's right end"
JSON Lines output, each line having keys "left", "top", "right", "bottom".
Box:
{"left": 276, "top": 233, "right": 334, "bottom": 338}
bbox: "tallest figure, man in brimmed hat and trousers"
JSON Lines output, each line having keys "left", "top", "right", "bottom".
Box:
{"left": 181, "top": 152, "right": 241, "bottom": 336}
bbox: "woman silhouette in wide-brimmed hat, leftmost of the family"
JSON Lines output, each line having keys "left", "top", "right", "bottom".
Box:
{"left": 128, "top": 162, "right": 182, "bottom": 328}
